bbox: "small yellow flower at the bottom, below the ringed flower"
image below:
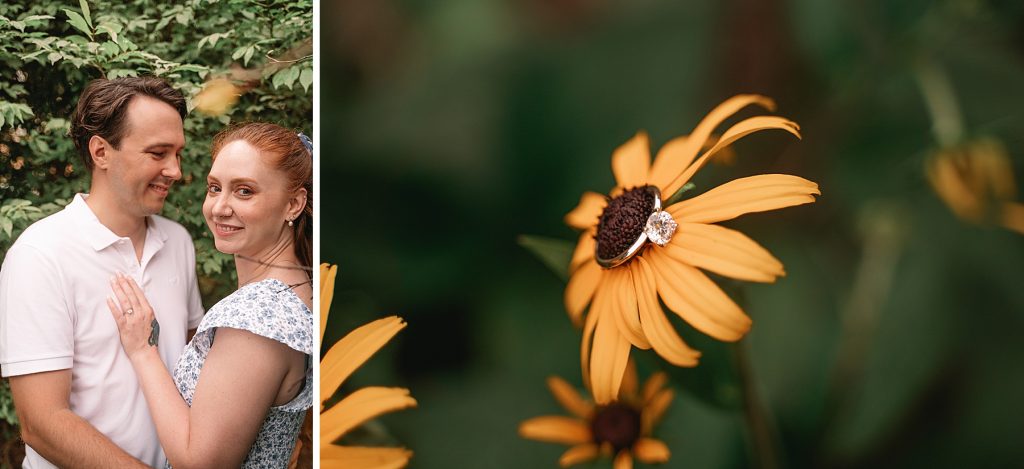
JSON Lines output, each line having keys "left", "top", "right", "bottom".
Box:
{"left": 519, "top": 363, "right": 674, "bottom": 469}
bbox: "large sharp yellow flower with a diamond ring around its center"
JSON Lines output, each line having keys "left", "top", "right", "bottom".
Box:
{"left": 565, "top": 95, "right": 820, "bottom": 404}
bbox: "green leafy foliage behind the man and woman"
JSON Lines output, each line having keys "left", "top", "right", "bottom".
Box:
{"left": 0, "top": 0, "right": 313, "bottom": 465}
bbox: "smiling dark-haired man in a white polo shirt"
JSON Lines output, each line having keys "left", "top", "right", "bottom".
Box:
{"left": 0, "top": 77, "right": 203, "bottom": 469}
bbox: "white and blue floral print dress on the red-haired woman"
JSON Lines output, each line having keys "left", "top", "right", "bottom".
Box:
{"left": 165, "top": 279, "right": 313, "bottom": 468}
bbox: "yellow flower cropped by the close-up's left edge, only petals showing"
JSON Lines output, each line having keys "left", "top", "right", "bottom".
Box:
{"left": 319, "top": 264, "right": 416, "bottom": 469}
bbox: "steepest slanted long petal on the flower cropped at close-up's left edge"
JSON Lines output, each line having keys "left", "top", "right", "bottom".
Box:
{"left": 321, "top": 316, "right": 406, "bottom": 403}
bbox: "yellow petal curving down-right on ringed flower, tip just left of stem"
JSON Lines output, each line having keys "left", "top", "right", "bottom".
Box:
{"left": 630, "top": 257, "right": 700, "bottom": 368}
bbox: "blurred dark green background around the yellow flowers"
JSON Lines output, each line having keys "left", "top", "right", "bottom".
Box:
{"left": 318, "top": 0, "right": 1024, "bottom": 468}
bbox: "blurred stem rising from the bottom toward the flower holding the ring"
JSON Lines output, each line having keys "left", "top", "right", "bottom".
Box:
{"left": 730, "top": 341, "right": 779, "bottom": 469}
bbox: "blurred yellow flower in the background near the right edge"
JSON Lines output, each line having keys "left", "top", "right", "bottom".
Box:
{"left": 926, "top": 138, "right": 1024, "bottom": 232}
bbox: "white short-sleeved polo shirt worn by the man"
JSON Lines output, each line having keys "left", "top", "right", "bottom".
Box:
{"left": 0, "top": 194, "right": 203, "bottom": 469}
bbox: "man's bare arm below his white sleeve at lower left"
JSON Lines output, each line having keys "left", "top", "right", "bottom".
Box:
{"left": 10, "top": 370, "right": 147, "bottom": 468}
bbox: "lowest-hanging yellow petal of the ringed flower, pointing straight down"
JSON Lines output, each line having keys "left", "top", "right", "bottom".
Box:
{"left": 590, "top": 290, "right": 630, "bottom": 406}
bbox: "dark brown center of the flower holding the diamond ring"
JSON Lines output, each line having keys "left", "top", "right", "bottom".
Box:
{"left": 597, "top": 186, "right": 654, "bottom": 259}
